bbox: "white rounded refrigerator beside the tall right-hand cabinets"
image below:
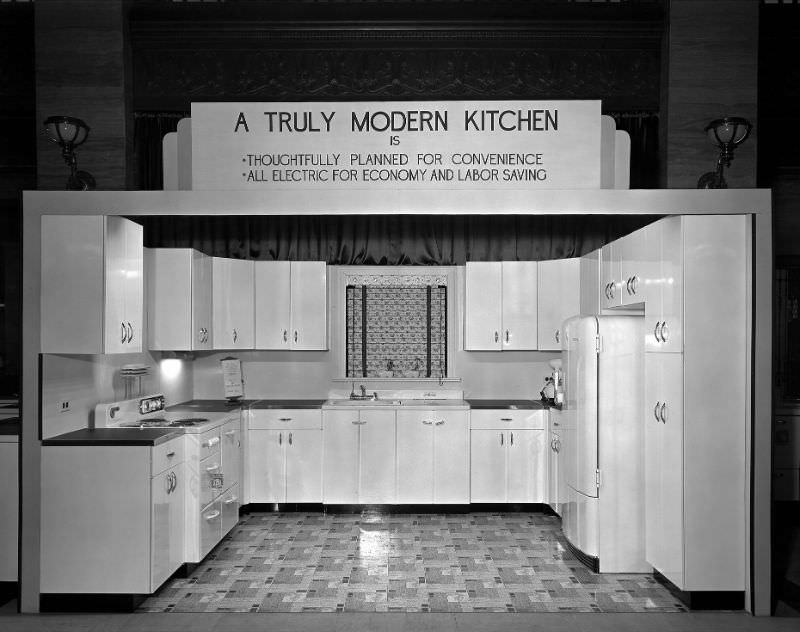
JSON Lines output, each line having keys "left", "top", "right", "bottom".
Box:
{"left": 561, "top": 316, "right": 651, "bottom": 573}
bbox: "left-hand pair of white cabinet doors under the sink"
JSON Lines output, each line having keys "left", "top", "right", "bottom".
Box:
{"left": 322, "top": 409, "right": 396, "bottom": 505}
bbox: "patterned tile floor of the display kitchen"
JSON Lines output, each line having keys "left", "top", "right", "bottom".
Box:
{"left": 139, "top": 512, "right": 686, "bottom": 613}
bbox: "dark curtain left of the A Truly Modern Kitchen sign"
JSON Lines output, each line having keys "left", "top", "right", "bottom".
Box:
{"left": 133, "top": 112, "right": 189, "bottom": 191}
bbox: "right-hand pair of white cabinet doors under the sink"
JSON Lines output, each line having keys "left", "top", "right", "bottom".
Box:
{"left": 397, "top": 409, "right": 469, "bottom": 504}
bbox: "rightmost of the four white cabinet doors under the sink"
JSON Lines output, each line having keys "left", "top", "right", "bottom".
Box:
{"left": 433, "top": 411, "right": 469, "bottom": 505}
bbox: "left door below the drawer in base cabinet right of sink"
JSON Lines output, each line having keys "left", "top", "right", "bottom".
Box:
{"left": 470, "top": 430, "right": 506, "bottom": 503}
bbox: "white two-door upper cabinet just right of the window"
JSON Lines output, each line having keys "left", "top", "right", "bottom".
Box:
{"left": 464, "top": 261, "right": 538, "bottom": 351}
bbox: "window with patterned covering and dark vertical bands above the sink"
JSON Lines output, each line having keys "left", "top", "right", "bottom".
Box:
{"left": 345, "top": 278, "right": 447, "bottom": 378}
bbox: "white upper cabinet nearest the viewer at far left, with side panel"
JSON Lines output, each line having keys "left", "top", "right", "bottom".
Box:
{"left": 41, "top": 215, "right": 144, "bottom": 354}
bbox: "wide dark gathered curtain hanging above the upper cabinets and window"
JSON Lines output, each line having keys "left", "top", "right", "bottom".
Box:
{"left": 141, "top": 215, "right": 657, "bottom": 265}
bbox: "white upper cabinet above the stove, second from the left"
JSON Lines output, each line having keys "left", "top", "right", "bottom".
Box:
{"left": 145, "top": 248, "right": 212, "bottom": 351}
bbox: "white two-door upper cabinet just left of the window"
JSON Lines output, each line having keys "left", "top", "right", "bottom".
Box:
{"left": 255, "top": 261, "right": 328, "bottom": 350}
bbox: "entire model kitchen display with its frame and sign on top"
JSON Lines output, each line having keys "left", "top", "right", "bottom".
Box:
{"left": 15, "top": 102, "right": 769, "bottom": 612}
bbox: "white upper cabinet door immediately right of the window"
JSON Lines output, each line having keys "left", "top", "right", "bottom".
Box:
{"left": 464, "top": 261, "right": 503, "bottom": 351}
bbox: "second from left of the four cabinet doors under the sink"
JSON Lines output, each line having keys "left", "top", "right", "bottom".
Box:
{"left": 358, "top": 410, "right": 397, "bottom": 504}
